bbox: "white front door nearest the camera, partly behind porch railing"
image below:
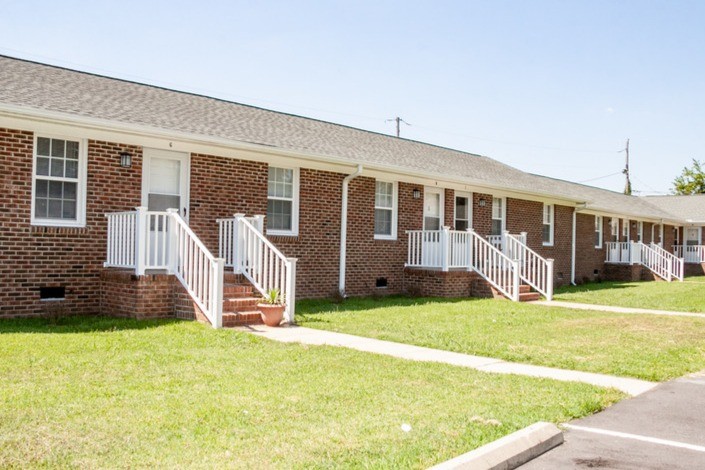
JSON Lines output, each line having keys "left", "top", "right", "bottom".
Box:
{"left": 142, "top": 149, "right": 189, "bottom": 269}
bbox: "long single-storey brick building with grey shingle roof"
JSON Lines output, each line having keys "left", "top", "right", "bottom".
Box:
{"left": 0, "top": 53, "right": 705, "bottom": 317}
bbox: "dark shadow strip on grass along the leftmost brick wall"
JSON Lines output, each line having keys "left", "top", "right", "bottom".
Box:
{"left": 0, "top": 315, "right": 183, "bottom": 335}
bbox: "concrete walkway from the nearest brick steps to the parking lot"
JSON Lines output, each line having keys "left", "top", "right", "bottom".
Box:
{"left": 238, "top": 325, "right": 658, "bottom": 396}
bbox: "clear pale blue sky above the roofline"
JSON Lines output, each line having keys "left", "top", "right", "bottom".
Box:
{"left": 0, "top": 0, "right": 705, "bottom": 194}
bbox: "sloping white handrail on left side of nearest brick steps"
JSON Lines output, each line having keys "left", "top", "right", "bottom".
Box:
{"left": 167, "top": 209, "right": 225, "bottom": 328}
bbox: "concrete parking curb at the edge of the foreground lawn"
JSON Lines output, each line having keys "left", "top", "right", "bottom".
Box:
{"left": 429, "top": 422, "right": 563, "bottom": 470}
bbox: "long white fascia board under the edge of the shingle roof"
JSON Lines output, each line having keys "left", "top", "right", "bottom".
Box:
{"left": 0, "top": 103, "right": 600, "bottom": 206}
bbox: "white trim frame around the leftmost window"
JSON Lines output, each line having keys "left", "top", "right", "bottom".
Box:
{"left": 30, "top": 132, "right": 88, "bottom": 228}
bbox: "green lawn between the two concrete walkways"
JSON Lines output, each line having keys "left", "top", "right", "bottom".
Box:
{"left": 297, "top": 297, "right": 705, "bottom": 381}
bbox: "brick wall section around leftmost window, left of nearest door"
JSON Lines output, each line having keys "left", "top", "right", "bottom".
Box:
{"left": 0, "top": 129, "right": 142, "bottom": 315}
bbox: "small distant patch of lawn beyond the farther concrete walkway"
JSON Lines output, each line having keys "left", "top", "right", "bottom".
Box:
{"left": 553, "top": 276, "right": 705, "bottom": 313}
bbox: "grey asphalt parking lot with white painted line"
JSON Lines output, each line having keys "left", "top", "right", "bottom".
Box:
{"left": 521, "top": 371, "right": 705, "bottom": 470}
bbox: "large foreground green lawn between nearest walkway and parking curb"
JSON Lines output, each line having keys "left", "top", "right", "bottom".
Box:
{"left": 0, "top": 318, "right": 623, "bottom": 468}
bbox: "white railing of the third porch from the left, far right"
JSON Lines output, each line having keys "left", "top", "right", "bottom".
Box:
{"left": 605, "top": 242, "right": 684, "bottom": 282}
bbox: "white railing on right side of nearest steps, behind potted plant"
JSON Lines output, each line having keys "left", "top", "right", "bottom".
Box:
{"left": 218, "top": 214, "right": 296, "bottom": 323}
